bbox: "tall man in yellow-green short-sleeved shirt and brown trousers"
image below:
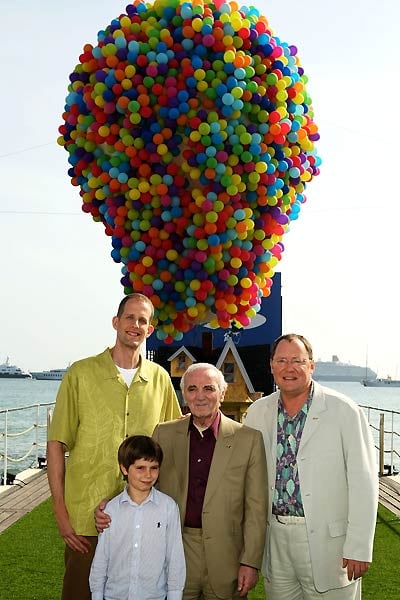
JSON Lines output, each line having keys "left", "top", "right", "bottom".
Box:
{"left": 47, "top": 294, "right": 181, "bottom": 600}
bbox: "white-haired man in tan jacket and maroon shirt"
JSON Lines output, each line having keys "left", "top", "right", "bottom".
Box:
{"left": 153, "top": 363, "right": 267, "bottom": 600}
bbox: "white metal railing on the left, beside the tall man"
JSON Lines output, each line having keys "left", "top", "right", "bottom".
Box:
{"left": 0, "top": 402, "right": 55, "bottom": 485}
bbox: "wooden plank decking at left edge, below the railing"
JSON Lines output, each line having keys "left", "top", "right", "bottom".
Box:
{"left": 0, "top": 469, "right": 50, "bottom": 533}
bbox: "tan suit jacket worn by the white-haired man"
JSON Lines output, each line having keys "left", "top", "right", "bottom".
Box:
{"left": 153, "top": 415, "right": 268, "bottom": 598}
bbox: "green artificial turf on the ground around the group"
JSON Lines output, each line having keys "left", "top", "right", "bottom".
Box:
{"left": 0, "top": 500, "right": 400, "bottom": 600}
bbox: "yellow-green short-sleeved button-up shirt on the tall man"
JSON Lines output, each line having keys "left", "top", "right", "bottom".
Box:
{"left": 48, "top": 349, "right": 181, "bottom": 535}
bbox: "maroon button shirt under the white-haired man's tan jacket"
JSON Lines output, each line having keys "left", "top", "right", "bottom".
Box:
{"left": 185, "top": 411, "right": 221, "bottom": 528}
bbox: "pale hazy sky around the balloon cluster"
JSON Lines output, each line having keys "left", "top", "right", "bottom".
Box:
{"left": 0, "top": 0, "right": 400, "bottom": 378}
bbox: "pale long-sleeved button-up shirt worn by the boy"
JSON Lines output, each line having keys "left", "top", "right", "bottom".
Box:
{"left": 89, "top": 488, "right": 186, "bottom": 600}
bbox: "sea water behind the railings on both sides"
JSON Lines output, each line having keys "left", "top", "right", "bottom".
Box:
{"left": 0, "top": 379, "right": 400, "bottom": 474}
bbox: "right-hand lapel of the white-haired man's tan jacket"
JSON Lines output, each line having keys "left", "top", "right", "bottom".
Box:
{"left": 204, "top": 414, "right": 237, "bottom": 506}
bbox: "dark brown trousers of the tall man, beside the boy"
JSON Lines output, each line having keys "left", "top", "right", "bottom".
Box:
{"left": 61, "top": 536, "right": 97, "bottom": 600}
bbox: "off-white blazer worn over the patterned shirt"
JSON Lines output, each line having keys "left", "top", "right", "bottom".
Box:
{"left": 245, "top": 382, "right": 378, "bottom": 592}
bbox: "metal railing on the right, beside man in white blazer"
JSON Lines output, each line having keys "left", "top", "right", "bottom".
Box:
{"left": 360, "top": 404, "right": 400, "bottom": 476}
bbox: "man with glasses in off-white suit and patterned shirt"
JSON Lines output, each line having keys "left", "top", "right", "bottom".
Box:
{"left": 245, "top": 334, "right": 378, "bottom": 600}
